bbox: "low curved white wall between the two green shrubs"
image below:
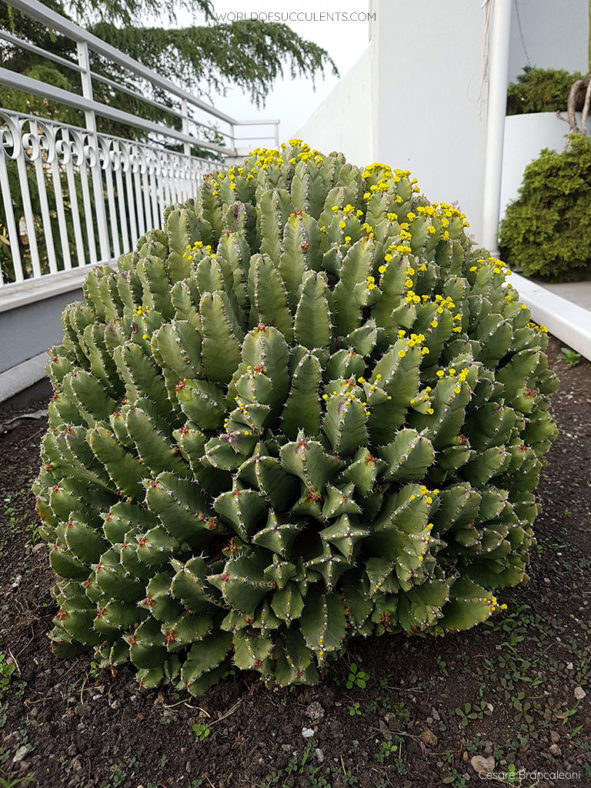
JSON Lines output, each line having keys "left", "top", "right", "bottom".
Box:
{"left": 501, "top": 112, "right": 591, "bottom": 219}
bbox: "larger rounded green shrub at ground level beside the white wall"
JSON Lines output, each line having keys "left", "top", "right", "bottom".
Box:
{"left": 499, "top": 134, "right": 591, "bottom": 281}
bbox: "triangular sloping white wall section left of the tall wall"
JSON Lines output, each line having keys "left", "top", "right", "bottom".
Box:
{"left": 295, "top": 48, "right": 375, "bottom": 167}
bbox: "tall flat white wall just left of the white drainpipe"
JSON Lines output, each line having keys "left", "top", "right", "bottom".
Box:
{"left": 372, "top": 0, "right": 490, "bottom": 243}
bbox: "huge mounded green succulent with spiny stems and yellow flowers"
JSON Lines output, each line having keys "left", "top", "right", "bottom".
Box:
{"left": 35, "top": 140, "right": 556, "bottom": 694}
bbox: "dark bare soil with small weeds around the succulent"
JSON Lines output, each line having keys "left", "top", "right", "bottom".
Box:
{"left": 0, "top": 340, "right": 591, "bottom": 788}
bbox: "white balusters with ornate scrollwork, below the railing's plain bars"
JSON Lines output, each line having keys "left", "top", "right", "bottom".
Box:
{"left": 0, "top": 109, "right": 217, "bottom": 285}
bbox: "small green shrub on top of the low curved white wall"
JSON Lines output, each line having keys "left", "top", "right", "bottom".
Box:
{"left": 507, "top": 66, "right": 583, "bottom": 115}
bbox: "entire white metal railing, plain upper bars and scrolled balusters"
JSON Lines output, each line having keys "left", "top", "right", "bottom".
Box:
{"left": 0, "top": 0, "right": 278, "bottom": 287}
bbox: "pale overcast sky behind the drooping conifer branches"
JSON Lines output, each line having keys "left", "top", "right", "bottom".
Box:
{"left": 178, "top": 0, "right": 369, "bottom": 147}
